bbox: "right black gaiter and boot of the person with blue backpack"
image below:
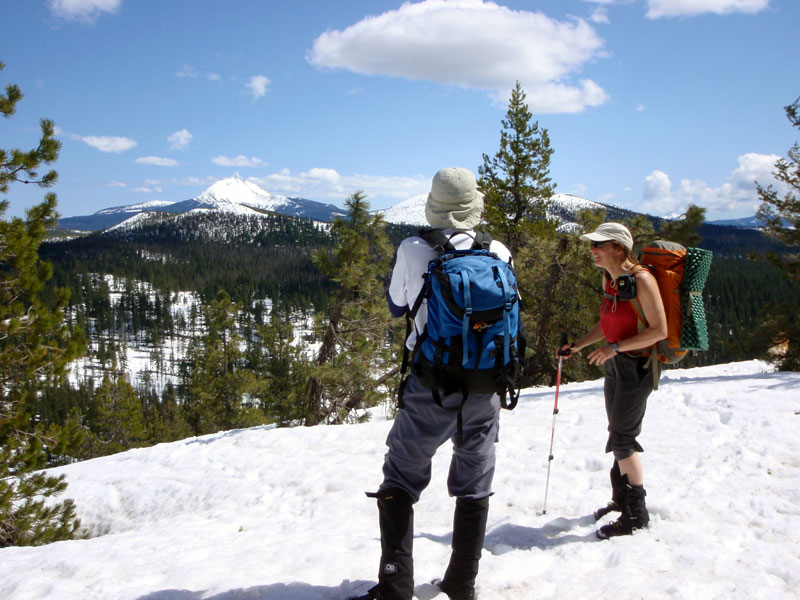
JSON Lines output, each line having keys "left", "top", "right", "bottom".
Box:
{"left": 437, "top": 496, "right": 489, "bottom": 600}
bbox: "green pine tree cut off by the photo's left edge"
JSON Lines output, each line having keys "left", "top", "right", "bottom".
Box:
{"left": 0, "top": 63, "right": 82, "bottom": 547}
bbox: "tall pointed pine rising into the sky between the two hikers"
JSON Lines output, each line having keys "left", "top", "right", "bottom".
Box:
{"left": 478, "top": 82, "right": 556, "bottom": 256}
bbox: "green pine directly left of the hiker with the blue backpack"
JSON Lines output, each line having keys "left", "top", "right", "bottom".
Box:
{"left": 305, "top": 191, "right": 398, "bottom": 425}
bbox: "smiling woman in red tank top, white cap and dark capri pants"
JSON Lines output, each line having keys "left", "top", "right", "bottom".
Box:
{"left": 561, "top": 223, "right": 667, "bottom": 539}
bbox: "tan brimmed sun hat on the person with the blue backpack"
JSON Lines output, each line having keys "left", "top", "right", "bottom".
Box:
{"left": 425, "top": 167, "right": 483, "bottom": 229}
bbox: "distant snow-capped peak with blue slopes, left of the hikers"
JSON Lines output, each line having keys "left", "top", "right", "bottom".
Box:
{"left": 58, "top": 173, "right": 345, "bottom": 231}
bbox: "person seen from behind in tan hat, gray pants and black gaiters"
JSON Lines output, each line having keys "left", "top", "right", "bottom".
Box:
{"left": 360, "top": 167, "right": 510, "bottom": 600}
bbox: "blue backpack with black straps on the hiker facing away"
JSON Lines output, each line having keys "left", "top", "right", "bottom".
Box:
{"left": 401, "top": 229, "right": 525, "bottom": 412}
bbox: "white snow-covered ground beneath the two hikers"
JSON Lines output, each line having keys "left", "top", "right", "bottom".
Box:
{"left": 0, "top": 361, "right": 800, "bottom": 600}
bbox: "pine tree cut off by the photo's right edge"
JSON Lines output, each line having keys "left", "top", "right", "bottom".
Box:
{"left": 755, "top": 97, "right": 800, "bottom": 371}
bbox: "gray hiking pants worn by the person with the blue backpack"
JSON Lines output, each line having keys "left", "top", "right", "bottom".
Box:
{"left": 380, "top": 375, "right": 500, "bottom": 502}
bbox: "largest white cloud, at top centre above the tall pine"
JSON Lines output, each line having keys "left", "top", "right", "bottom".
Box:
{"left": 306, "top": 0, "right": 607, "bottom": 112}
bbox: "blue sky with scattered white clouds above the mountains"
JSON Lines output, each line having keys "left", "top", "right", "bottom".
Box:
{"left": 0, "top": 0, "right": 800, "bottom": 219}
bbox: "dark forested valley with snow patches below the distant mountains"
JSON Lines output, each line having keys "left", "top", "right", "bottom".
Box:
{"left": 28, "top": 204, "right": 800, "bottom": 458}
